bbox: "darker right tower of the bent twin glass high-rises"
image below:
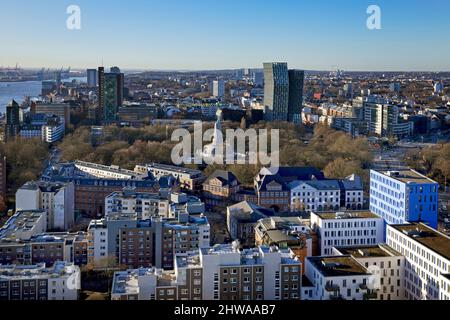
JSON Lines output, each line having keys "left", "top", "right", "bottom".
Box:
{"left": 288, "top": 70, "right": 305, "bottom": 123}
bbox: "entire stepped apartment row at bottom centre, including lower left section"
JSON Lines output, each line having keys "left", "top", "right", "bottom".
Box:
{"left": 112, "top": 245, "right": 302, "bottom": 300}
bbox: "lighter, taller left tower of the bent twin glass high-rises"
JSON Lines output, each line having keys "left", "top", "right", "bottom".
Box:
{"left": 264, "top": 62, "right": 289, "bottom": 121}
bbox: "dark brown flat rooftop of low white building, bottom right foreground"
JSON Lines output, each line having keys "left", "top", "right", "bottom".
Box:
{"left": 307, "top": 256, "right": 369, "bottom": 277}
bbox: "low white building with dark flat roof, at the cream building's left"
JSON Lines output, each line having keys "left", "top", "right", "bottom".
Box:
{"left": 305, "top": 256, "right": 377, "bottom": 300}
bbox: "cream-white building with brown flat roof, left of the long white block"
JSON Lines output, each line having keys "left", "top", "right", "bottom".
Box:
{"left": 333, "top": 244, "right": 405, "bottom": 300}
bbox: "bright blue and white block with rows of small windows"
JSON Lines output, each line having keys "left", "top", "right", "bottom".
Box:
{"left": 370, "top": 170, "right": 439, "bottom": 228}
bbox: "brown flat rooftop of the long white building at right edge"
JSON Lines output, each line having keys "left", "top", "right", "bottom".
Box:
{"left": 390, "top": 223, "right": 450, "bottom": 260}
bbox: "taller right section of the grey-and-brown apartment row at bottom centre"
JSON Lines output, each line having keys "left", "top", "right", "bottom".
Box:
{"left": 180, "top": 243, "right": 302, "bottom": 300}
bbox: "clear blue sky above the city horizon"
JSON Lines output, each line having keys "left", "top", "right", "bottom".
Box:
{"left": 0, "top": 0, "right": 450, "bottom": 71}
